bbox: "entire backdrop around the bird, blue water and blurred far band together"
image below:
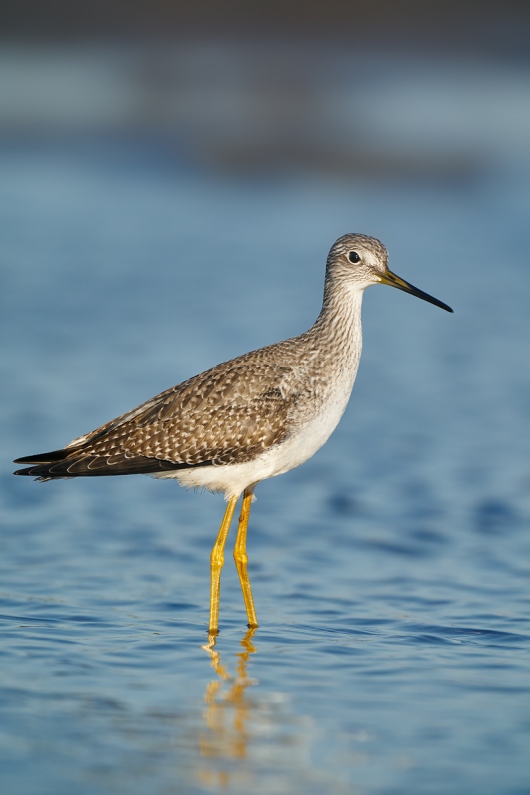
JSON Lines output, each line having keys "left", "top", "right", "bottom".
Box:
{"left": 0, "top": 0, "right": 530, "bottom": 795}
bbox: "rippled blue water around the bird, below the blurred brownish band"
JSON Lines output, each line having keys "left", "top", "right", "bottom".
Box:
{"left": 0, "top": 134, "right": 530, "bottom": 795}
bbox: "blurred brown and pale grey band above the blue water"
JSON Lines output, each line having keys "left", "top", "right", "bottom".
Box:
{"left": 0, "top": 0, "right": 530, "bottom": 181}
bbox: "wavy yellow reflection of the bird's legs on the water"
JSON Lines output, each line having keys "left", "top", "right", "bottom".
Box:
{"left": 199, "top": 629, "right": 257, "bottom": 787}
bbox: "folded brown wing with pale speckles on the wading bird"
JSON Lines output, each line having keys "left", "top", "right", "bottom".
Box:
{"left": 14, "top": 349, "right": 296, "bottom": 479}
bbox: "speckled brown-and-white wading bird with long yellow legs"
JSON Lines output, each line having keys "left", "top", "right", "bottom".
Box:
{"left": 14, "top": 233, "right": 453, "bottom": 638}
